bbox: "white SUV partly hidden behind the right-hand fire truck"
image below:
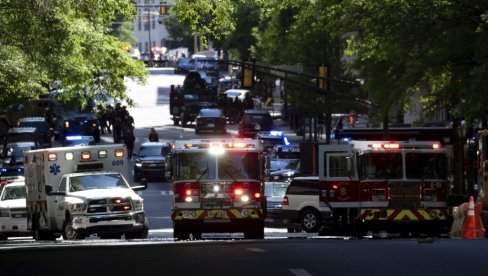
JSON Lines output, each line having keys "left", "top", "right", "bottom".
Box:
{"left": 282, "top": 176, "right": 332, "bottom": 233}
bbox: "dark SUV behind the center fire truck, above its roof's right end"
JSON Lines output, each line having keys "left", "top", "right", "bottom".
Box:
{"left": 238, "top": 109, "right": 275, "bottom": 138}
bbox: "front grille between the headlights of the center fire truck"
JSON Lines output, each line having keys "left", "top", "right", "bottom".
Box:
{"left": 200, "top": 183, "right": 232, "bottom": 208}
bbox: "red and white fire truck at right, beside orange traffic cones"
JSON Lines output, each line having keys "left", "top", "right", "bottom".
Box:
{"left": 318, "top": 141, "right": 452, "bottom": 236}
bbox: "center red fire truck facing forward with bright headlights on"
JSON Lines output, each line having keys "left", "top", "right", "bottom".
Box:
{"left": 171, "top": 138, "right": 269, "bottom": 240}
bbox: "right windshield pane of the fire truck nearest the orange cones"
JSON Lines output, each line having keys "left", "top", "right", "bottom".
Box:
{"left": 405, "top": 152, "right": 447, "bottom": 179}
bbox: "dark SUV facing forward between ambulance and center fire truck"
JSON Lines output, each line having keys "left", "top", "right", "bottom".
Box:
{"left": 134, "top": 142, "right": 171, "bottom": 182}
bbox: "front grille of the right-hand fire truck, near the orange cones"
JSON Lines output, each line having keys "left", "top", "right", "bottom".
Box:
{"left": 389, "top": 182, "right": 420, "bottom": 208}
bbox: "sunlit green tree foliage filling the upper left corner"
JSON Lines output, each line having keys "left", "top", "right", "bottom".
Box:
{"left": 0, "top": 0, "right": 146, "bottom": 106}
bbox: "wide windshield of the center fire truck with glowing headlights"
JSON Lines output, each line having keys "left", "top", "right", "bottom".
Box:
{"left": 175, "top": 151, "right": 261, "bottom": 180}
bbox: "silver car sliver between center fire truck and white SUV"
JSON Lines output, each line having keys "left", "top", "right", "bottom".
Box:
{"left": 264, "top": 182, "right": 289, "bottom": 228}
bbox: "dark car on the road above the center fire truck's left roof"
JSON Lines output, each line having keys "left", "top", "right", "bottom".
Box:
{"left": 195, "top": 108, "right": 227, "bottom": 134}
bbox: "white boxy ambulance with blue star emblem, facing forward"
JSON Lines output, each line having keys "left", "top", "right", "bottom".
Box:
{"left": 24, "top": 144, "right": 149, "bottom": 240}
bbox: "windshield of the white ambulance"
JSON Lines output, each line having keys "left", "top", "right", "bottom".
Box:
{"left": 69, "top": 174, "right": 130, "bottom": 192}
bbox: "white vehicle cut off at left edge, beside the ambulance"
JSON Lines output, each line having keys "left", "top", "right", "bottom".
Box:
{"left": 0, "top": 180, "right": 32, "bottom": 240}
